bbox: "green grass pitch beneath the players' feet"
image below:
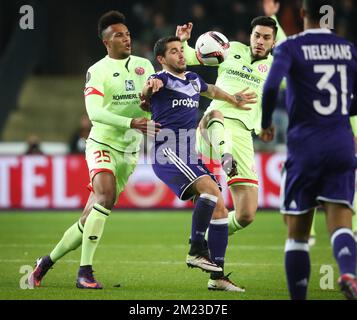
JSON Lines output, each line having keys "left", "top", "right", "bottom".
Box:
{"left": 0, "top": 211, "right": 343, "bottom": 300}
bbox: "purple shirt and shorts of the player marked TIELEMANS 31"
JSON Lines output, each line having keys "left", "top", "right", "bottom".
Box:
{"left": 262, "top": 29, "right": 357, "bottom": 214}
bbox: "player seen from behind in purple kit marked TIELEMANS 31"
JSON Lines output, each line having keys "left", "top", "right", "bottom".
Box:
{"left": 261, "top": 0, "right": 357, "bottom": 299}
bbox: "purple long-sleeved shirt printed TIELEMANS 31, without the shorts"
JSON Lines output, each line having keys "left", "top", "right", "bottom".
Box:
{"left": 262, "top": 29, "right": 357, "bottom": 168}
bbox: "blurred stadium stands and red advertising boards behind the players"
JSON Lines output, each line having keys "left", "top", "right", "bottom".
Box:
{"left": 0, "top": 0, "right": 357, "bottom": 209}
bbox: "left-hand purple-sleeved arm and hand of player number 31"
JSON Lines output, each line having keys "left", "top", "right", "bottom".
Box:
{"left": 260, "top": 42, "right": 292, "bottom": 142}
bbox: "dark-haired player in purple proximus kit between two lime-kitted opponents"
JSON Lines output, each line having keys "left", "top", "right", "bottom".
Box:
{"left": 142, "top": 36, "right": 256, "bottom": 292}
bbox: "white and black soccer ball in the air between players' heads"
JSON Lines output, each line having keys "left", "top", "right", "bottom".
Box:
{"left": 195, "top": 31, "right": 230, "bottom": 66}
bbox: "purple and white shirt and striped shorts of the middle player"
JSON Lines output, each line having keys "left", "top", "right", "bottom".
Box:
{"left": 151, "top": 71, "right": 219, "bottom": 200}
